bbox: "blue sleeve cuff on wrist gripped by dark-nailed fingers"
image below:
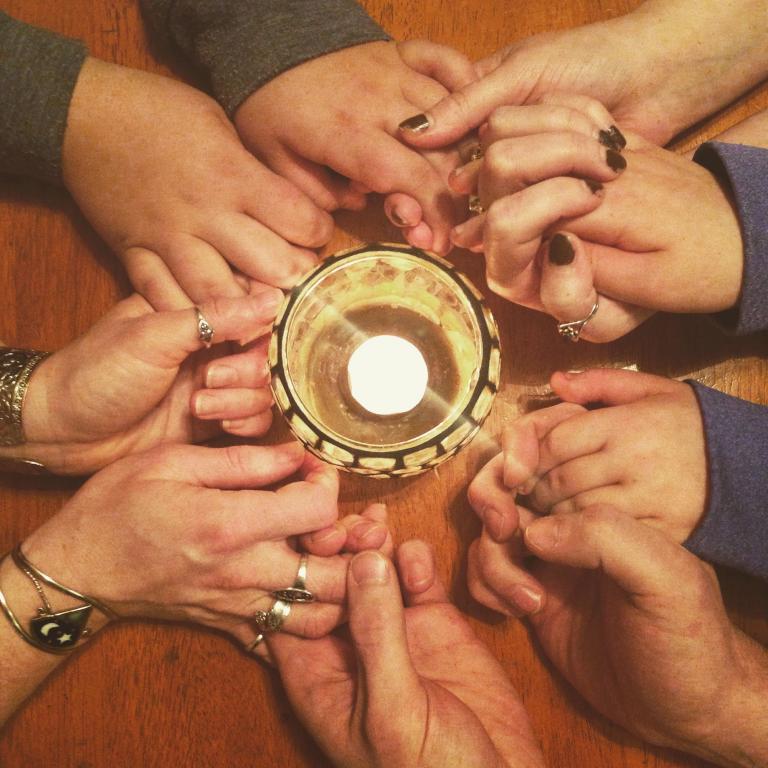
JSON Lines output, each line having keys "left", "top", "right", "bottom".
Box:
{"left": 693, "top": 142, "right": 768, "bottom": 334}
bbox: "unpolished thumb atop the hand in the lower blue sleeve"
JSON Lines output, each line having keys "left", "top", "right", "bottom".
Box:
{"left": 550, "top": 368, "right": 680, "bottom": 405}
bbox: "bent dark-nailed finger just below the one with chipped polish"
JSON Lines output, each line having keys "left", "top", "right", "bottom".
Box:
{"left": 478, "top": 133, "right": 627, "bottom": 205}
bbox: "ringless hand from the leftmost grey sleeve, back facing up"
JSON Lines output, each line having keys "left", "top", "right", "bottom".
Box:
{"left": 62, "top": 59, "right": 333, "bottom": 309}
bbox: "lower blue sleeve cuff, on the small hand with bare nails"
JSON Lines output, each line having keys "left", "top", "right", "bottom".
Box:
{"left": 685, "top": 381, "right": 768, "bottom": 580}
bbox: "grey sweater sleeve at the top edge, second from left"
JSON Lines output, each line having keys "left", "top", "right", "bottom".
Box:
{"left": 141, "top": 0, "right": 389, "bottom": 115}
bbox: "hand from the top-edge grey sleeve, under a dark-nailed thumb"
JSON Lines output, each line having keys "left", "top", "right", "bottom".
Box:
{"left": 234, "top": 41, "right": 475, "bottom": 252}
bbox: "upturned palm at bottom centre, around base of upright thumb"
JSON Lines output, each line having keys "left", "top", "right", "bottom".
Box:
{"left": 281, "top": 604, "right": 538, "bottom": 768}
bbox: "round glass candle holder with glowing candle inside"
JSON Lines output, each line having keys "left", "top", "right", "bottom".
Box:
{"left": 269, "top": 244, "right": 500, "bottom": 477}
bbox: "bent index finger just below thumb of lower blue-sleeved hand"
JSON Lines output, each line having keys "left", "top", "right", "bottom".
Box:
{"left": 502, "top": 403, "right": 585, "bottom": 493}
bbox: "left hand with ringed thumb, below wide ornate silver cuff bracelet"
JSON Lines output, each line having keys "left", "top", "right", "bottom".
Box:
{"left": 0, "top": 288, "right": 282, "bottom": 474}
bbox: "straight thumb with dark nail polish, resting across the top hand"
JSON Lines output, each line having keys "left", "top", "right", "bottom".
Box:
{"left": 400, "top": 69, "right": 509, "bottom": 149}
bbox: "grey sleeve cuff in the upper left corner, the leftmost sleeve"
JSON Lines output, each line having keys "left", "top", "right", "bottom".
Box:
{"left": 0, "top": 13, "right": 88, "bottom": 183}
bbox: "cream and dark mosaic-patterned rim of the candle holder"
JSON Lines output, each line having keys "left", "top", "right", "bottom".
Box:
{"left": 269, "top": 243, "right": 501, "bottom": 478}
